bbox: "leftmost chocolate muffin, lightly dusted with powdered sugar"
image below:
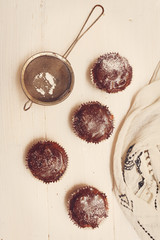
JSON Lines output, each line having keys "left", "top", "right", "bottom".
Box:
{"left": 26, "top": 141, "right": 68, "bottom": 183}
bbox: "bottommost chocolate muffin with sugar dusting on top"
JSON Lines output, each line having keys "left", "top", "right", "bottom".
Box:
{"left": 68, "top": 186, "right": 108, "bottom": 228}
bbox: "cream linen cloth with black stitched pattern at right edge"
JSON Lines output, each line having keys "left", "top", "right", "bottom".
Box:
{"left": 113, "top": 62, "right": 160, "bottom": 240}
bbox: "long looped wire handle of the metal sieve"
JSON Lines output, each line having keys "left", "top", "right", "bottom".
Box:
{"left": 63, "top": 4, "right": 104, "bottom": 58}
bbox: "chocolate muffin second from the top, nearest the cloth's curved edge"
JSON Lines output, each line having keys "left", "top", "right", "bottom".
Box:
{"left": 72, "top": 101, "right": 113, "bottom": 143}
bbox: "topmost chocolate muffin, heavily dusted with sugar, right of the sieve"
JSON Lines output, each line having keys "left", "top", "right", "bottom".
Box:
{"left": 91, "top": 53, "right": 132, "bottom": 93}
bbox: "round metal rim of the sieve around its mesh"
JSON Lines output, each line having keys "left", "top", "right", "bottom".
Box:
{"left": 21, "top": 51, "right": 75, "bottom": 106}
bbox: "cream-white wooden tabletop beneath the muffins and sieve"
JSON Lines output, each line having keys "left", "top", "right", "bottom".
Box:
{"left": 0, "top": 0, "right": 160, "bottom": 240}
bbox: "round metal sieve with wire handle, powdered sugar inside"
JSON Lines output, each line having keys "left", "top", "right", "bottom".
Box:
{"left": 21, "top": 5, "right": 104, "bottom": 111}
